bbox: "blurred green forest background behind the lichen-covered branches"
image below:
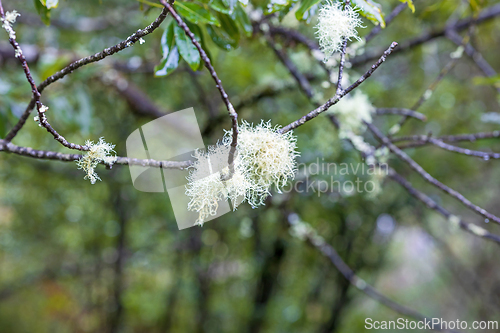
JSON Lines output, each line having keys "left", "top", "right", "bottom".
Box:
{"left": 0, "top": 0, "right": 500, "bottom": 333}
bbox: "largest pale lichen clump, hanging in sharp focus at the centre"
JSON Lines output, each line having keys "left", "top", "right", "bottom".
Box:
{"left": 186, "top": 122, "right": 298, "bottom": 225}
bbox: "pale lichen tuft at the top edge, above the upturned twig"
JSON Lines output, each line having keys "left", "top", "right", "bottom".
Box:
{"left": 316, "top": 0, "right": 363, "bottom": 62}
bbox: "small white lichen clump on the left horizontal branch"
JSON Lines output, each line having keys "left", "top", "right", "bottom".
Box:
{"left": 76, "top": 138, "right": 116, "bottom": 184}
